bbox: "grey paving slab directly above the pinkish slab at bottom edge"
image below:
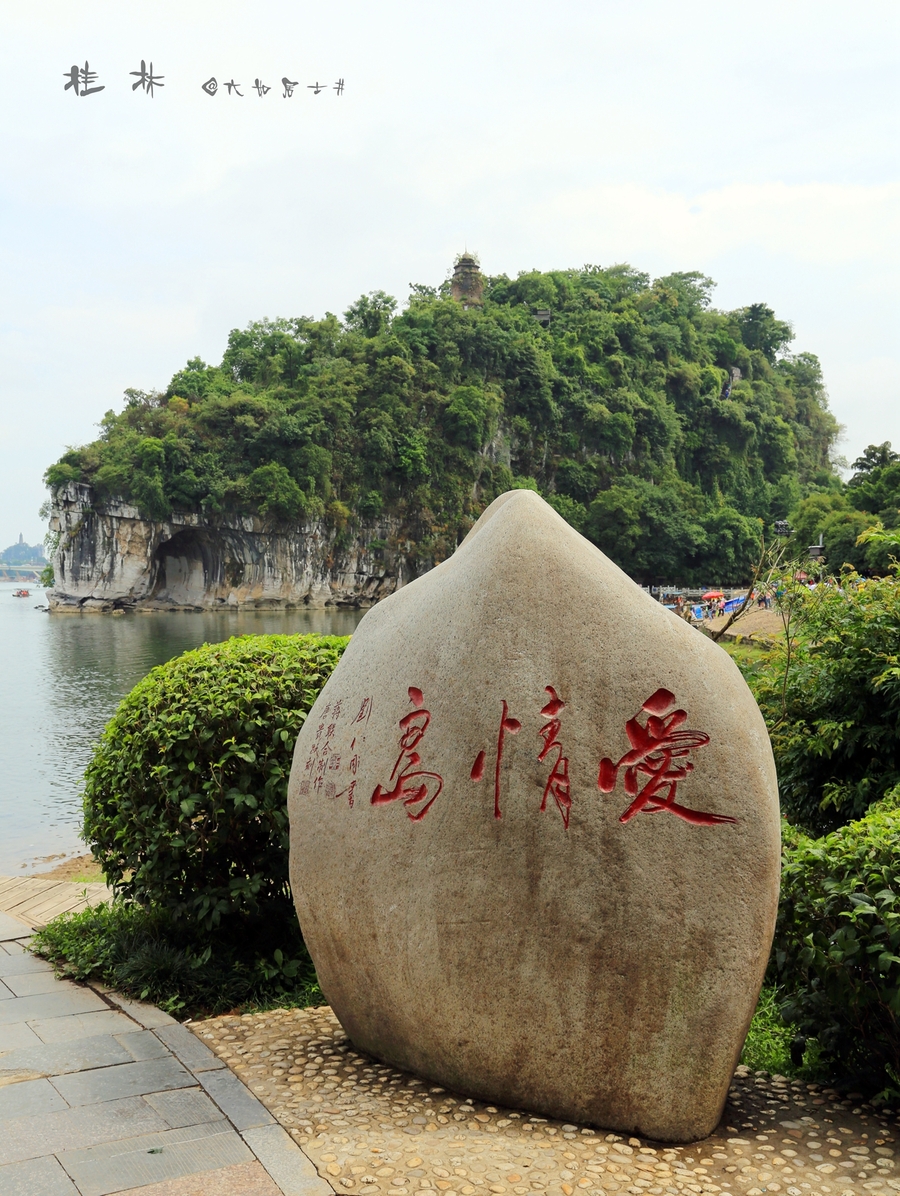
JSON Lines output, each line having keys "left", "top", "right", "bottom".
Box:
{"left": 59, "top": 1121, "right": 253, "bottom": 1196}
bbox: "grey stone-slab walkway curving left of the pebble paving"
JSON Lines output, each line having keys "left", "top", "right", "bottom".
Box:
{"left": 0, "top": 899, "right": 333, "bottom": 1196}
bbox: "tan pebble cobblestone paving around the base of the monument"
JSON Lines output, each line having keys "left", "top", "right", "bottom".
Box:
{"left": 190, "top": 1006, "right": 900, "bottom": 1196}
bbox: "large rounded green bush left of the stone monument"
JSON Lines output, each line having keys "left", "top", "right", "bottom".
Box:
{"left": 84, "top": 635, "right": 348, "bottom": 929}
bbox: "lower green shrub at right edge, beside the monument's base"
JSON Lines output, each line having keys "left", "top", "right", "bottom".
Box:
{"left": 770, "top": 787, "right": 900, "bottom": 1091}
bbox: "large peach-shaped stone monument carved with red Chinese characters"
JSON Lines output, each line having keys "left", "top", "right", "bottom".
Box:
{"left": 289, "top": 490, "right": 779, "bottom": 1141}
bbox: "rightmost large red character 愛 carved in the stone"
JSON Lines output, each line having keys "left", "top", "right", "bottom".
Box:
{"left": 596, "top": 689, "right": 736, "bottom": 826}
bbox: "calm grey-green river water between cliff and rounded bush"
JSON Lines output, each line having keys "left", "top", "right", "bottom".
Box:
{"left": 0, "top": 582, "right": 365, "bottom": 875}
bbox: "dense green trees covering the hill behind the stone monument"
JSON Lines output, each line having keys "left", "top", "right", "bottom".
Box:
{"left": 47, "top": 266, "right": 840, "bottom": 582}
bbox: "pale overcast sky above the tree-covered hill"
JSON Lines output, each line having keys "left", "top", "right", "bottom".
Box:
{"left": 0, "top": 0, "right": 900, "bottom": 548}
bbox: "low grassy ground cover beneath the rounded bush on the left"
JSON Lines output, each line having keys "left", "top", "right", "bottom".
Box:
{"left": 32, "top": 901, "right": 324, "bottom": 1018}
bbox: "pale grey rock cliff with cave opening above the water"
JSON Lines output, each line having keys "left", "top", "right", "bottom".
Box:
{"left": 48, "top": 482, "right": 416, "bottom": 611}
